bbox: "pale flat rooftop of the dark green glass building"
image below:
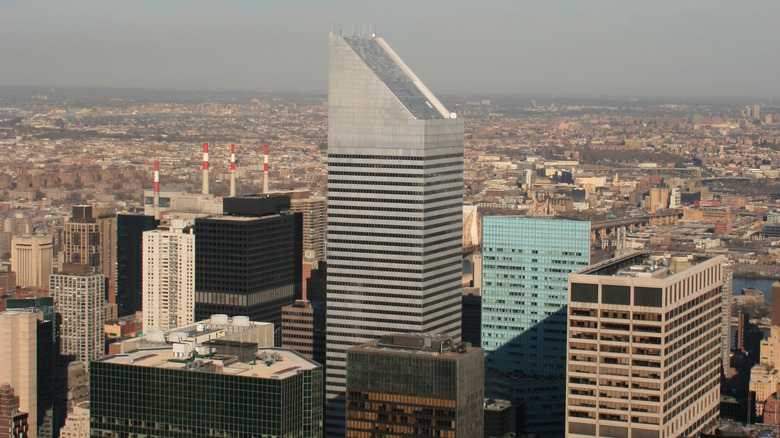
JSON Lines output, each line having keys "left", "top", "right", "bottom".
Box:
{"left": 97, "top": 347, "right": 320, "bottom": 379}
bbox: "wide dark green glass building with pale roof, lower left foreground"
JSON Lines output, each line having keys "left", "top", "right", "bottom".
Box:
{"left": 89, "top": 344, "right": 323, "bottom": 438}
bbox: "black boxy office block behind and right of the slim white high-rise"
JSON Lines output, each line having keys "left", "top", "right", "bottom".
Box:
{"left": 195, "top": 195, "right": 303, "bottom": 327}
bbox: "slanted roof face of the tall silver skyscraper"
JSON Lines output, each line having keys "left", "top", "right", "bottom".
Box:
{"left": 344, "top": 36, "right": 450, "bottom": 119}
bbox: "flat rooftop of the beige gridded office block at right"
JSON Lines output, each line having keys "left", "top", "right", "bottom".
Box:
{"left": 576, "top": 252, "right": 718, "bottom": 279}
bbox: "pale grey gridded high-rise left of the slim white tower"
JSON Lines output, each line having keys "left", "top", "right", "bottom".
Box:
{"left": 49, "top": 274, "right": 106, "bottom": 364}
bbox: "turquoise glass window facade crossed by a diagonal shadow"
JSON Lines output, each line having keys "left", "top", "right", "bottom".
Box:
{"left": 482, "top": 216, "right": 590, "bottom": 375}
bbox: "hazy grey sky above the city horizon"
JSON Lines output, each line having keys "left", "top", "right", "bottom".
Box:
{"left": 0, "top": 0, "right": 780, "bottom": 97}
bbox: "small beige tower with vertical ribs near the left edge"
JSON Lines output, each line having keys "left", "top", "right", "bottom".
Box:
{"left": 11, "top": 235, "right": 54, "bottom": 288}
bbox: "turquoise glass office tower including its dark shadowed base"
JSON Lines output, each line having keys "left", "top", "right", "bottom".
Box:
{"left": 481, "top": 216, "right": 590, "bottom": 436}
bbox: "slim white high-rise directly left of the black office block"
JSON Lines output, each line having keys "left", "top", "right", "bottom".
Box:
{"left": 143, "top": 220, "right": 195, "bottom": 333}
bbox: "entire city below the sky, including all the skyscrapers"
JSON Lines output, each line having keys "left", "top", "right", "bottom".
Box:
{"left": 0, "top": 33, "right": 780, "bottom": 438}
